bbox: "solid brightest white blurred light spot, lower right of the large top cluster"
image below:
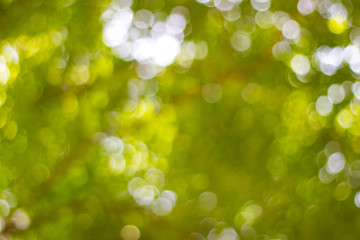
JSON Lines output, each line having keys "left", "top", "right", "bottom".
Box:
{"left": 153, "top": 34, "right": 180, "bottom": 67}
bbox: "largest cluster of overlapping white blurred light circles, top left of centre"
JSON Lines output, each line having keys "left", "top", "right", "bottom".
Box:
{"left": 101, "top": 0, "right": 187, "bottom": 75}
